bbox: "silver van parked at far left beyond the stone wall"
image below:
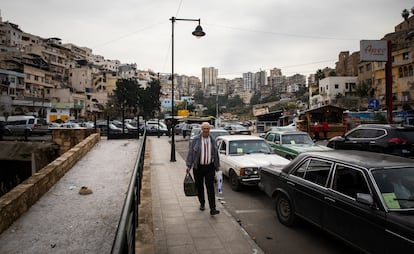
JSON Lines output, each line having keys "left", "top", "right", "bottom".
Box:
{"left": 5, "top": 116, "right": 49, "bottom": 136}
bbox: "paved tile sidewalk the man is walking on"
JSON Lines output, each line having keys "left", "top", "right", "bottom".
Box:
{"left": 147, "top": 136, "right": 263, "bottom": 254}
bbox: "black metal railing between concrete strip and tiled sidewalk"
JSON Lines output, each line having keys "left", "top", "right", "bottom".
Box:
{"left": 111, "top": 131, "right": 147, "bottom": 254}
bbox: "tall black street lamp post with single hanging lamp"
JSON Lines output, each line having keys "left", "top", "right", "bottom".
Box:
{"left": 170, "top": 17, "right": 206, "bottom": 162}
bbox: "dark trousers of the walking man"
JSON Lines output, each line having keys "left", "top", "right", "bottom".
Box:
{"left": 193, "top": 164, "right": 216, "bottom": 210}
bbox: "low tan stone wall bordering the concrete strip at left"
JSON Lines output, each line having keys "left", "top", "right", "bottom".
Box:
{"left": 0, "top": 132, "right": 101, "bottom": 234}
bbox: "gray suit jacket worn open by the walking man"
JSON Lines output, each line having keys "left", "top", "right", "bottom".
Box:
{"left": 185, "top": 134, "right": 220, "bottom": 170}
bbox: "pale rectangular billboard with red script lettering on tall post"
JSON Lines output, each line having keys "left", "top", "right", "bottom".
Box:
{"left": 360, "top": 40, "right": 388, "bottom": 62}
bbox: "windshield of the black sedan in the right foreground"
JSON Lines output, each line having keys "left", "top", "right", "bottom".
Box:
{"left": 372, "top": 167, "right": 414, "bottom": 209}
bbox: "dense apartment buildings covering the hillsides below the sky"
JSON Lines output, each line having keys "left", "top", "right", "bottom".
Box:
{"left": 0, "top": 8, "right": 414, "bottom": 121}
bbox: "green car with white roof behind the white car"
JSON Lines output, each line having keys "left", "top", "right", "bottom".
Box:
{"left": 264, "top": 131, "right": 332, "bottom": 160}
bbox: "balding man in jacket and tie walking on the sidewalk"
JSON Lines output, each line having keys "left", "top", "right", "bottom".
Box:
{"left": 186, "top": 122, "right": 220, "bottom": 216}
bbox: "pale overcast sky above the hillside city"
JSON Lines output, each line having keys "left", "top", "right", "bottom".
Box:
{"left": 0, "top": 0, "right": 414, "bottom": 78}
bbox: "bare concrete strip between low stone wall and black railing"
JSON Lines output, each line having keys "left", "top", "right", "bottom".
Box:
{"left": 0, "top": 138, "right": 142, "bottom": 254}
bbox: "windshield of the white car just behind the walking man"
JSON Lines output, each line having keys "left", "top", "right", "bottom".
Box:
{"left": 229, "top": 140, "right": 271, "bottom": 155}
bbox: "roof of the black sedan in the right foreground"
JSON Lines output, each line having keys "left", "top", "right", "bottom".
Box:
{"left": 296, "top": 150, "right": 414, "bottom": 168}
